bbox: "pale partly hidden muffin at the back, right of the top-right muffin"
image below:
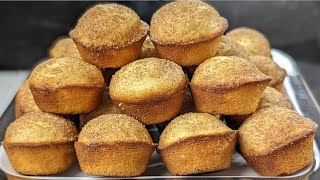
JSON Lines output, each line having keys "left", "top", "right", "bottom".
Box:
{"left": 226, "top": 27, "right": 271, "bottom": 57}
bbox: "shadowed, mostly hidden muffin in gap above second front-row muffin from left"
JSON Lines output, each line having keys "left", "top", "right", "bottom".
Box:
{"left": 79, "top": 89, "right": 120, "bottom": 129}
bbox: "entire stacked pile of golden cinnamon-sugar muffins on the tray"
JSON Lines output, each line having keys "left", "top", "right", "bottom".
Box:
{"left": 2, "top": 0, "right": 317, "bottom": 176}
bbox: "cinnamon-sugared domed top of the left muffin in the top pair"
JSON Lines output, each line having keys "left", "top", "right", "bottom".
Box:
{"left": 70, "top": 3, "right": 142, "bottom": 47}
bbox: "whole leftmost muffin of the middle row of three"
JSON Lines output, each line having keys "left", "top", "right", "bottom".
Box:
{"left": 29, "top": 57, "right": 105, "bottom": 114}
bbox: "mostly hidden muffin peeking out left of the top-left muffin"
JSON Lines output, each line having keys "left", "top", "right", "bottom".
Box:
{"left": 49, "top": 37, "right": 82, "bottom": 59}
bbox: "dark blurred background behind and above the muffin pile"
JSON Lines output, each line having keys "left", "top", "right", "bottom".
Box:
{"left": 0, "top": 1, "right": 320, "bottom": 99}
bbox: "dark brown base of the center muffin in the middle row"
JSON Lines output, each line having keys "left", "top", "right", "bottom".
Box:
{"left": 114, "top": 90, "right": 185, "bottom": 125}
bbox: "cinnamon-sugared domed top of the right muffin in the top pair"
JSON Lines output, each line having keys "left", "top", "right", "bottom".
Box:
{"left": 150, "top": 1, "right": 226, "bottom": 44}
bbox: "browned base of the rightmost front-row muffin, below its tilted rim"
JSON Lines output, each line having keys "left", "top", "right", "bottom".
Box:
{"left": 240, "top": 132, "right": 314, "bottom": 176}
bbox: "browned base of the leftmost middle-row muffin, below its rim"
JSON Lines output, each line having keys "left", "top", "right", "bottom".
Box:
{"left": 30, "top": 85, "right": 105, "bottom": 114}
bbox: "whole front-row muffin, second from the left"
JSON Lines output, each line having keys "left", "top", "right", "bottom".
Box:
{"left": 75, "top": 114, "right": 155, "bottom": 176}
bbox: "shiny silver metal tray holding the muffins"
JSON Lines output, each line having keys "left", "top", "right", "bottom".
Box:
{"left": 0, "top": 49, "right": 320, "bottom": 179}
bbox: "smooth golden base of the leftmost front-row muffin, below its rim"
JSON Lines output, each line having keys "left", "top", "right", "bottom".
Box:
{"left": 2, "top": 142, "right": 75, "bottom": 175}
